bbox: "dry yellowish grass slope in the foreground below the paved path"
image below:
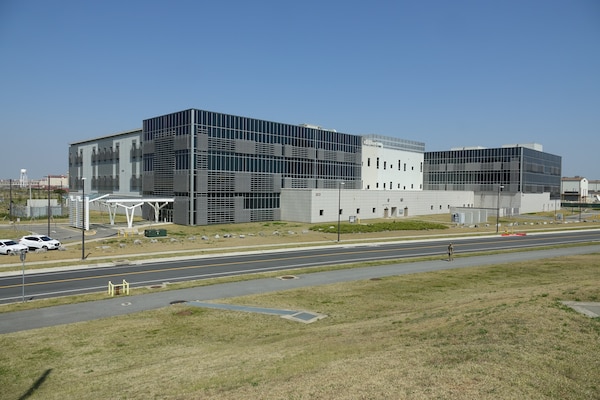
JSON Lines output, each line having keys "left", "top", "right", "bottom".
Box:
{"left": 0, "top": 255, "right": 600, "bottom": 399}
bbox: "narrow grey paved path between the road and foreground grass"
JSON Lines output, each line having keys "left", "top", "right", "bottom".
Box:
{"left": 0, "top": 245, "right": 600, "bottom": 334}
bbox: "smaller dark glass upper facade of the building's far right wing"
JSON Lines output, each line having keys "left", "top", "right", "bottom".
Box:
{"left": 423, "top": 144, "right": 562, "bottom": 199}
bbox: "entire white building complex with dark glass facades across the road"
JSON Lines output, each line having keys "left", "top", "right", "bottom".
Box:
{"left": 69, "top": 109, "right": 561, "bottom": 225}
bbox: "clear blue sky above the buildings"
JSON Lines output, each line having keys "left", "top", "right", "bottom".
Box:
{"left": 0, "top": 0, "right": 600, "bottom": 179}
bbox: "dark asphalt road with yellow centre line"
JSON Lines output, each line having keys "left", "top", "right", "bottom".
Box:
{"left": 0, "top": 230, "right": 600, "bottom": 304}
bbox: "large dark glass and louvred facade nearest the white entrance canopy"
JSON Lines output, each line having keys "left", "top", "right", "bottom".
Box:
{"left": 142, "top": 109, "right": 362, "bottom": 225}
